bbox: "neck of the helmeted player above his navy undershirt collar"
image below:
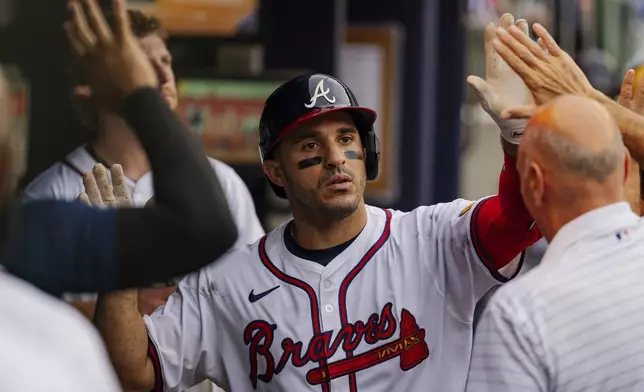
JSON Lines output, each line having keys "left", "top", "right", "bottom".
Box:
{"left": 292, "top": 202, "right": 367, "bottom": 250}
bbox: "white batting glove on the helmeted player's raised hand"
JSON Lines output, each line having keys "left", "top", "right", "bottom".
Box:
{"left": 467, "top": 14, "right": 534, "bottom": 144}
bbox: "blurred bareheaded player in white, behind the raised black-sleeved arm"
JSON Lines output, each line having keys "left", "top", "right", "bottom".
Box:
{"left": 24, "top": 10, "right": 264, "bottom": 324}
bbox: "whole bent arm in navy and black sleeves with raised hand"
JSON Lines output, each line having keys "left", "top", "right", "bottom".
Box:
{"left": 3, "top": 0, "right": 237, "bottom": 293}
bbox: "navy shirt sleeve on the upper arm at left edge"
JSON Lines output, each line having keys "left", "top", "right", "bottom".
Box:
{"left": 2, "top": 200, "right": 118, "bottom": 295}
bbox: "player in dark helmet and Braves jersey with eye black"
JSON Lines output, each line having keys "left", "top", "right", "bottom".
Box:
{"left": 95, "top": 12, "right": 540, "bottom": 392}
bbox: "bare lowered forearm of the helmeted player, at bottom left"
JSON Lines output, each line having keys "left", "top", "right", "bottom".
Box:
{"left": 94, "top": 290, "right": 155, "bottom": 392}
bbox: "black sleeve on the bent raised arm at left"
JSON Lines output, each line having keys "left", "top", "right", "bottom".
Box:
{"left": 117, "top": 89, "right": 237, "bottom": 286}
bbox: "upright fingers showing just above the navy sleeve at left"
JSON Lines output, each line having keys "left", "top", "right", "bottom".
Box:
{"left": 78, "top": 163, "right": 132, "bottom": 208}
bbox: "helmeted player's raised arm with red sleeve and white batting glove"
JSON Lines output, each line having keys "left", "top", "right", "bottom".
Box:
{"left": 468, "top": 14, "right": 540, "bottom": 280}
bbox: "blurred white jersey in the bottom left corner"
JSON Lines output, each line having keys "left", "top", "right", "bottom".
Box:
{"left": 0, "top": 271, "right": 121, "bottom": 392}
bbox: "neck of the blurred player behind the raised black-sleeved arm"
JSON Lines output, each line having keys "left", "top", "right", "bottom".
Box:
{"left": 92, "top": 113, "right": 150, "bottom": 181}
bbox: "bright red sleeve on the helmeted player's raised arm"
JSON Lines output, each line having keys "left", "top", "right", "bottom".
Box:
{"left": 472, "top": 154, "right": 541, "bottom": 270}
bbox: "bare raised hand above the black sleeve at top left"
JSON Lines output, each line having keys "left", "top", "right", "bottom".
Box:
{"left": 65, "top": 0, "right": 158, "bottom": 107}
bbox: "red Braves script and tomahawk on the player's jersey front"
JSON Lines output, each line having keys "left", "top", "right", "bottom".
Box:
{"left": 244, "top": 302, "right": 429, "bottom": 389}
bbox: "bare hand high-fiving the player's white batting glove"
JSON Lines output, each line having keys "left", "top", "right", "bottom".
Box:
{"left": 492, "top": 23, "right": 601, "bottom": 105}
